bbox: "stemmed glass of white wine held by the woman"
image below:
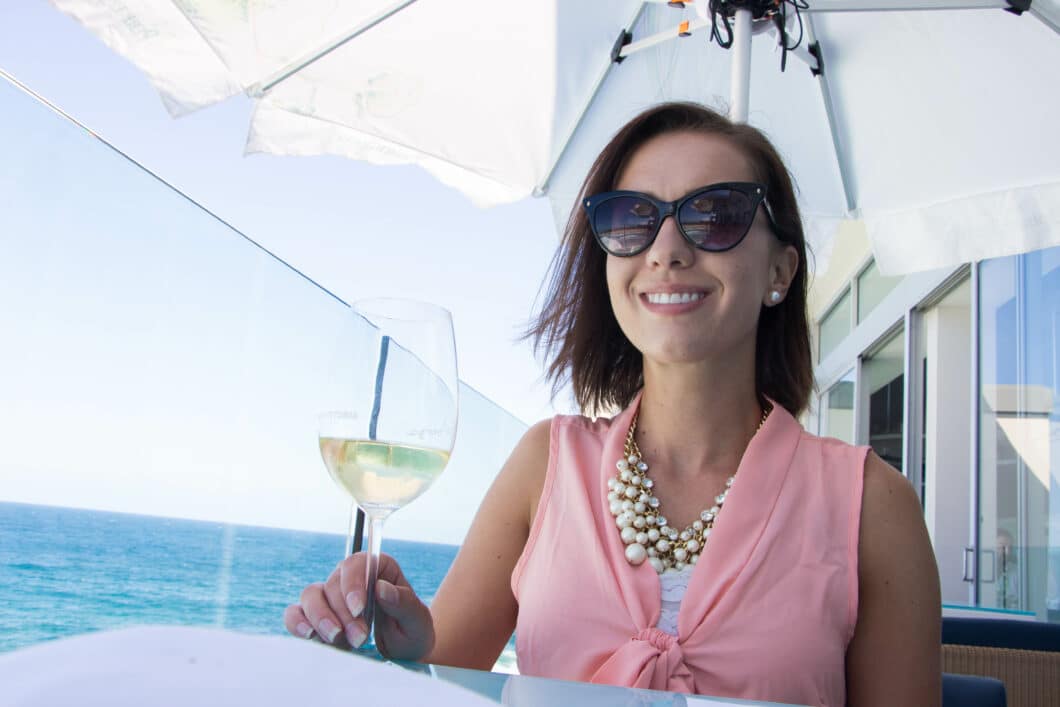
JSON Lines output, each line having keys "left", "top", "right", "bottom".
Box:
{"left": 318, "top": 299, "right": 457, "bottom": 655}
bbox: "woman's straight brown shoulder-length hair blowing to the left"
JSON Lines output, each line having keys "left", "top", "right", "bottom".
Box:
{"left": 526, "top": 103, "right": 814, "bottom": 416}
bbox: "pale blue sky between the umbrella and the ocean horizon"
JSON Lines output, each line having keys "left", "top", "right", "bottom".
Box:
{"left": 0, "top": 2, "right": 569, "bottom": 542}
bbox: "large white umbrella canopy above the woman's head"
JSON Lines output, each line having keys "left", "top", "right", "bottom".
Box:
{"left": 52, "top": 0, "right": 1060, "bottom": 273}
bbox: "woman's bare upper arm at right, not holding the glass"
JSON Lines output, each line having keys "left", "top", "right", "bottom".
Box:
{"left": 847, "top": 453, "right": 942, "bottom": 707}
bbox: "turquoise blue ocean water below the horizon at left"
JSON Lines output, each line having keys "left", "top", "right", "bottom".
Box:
{"left": 0, "top": 502, "right": 515, "bottom": 672}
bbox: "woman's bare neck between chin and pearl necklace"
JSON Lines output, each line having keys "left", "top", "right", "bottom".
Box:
{"left": 637, "top": 357, "right": 763, "bottom": 476}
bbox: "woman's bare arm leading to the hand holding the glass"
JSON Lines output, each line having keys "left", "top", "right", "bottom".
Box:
{"left": 424, "top": 421, "right": 549, "bottom": 670}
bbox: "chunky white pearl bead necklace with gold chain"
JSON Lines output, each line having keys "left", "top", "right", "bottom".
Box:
{"left": 607, "top": 408, "right": 770, "bottom": 575}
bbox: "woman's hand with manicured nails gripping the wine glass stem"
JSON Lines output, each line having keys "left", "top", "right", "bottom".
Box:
{"left": 283, "top": 552, "right": 435, "bottom": 660}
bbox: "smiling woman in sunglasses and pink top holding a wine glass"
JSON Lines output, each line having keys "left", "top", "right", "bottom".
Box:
{"left": 285, "top": 104, "right": 940, "bottom": 706}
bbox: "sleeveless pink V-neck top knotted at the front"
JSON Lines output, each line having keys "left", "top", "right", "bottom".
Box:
{"left": 512, "top": 397, "right": 867, "bottom": 707}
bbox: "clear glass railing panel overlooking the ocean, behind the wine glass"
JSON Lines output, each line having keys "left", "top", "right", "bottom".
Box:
{"left": 0, "top": 67, "right": 526, "bottom": 651}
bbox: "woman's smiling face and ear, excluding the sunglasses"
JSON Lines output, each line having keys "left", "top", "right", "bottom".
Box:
{"left": 607, "top": 132, "right": 798, "bottom": 365}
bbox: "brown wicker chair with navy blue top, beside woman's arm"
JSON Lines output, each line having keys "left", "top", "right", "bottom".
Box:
{"left": 942, "top": 617, "right": 1060, "bottom": 707}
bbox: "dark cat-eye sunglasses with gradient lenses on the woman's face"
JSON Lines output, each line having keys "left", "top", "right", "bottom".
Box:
{"left": 584, "top": 181, "right": 777, "bottom": 258}
